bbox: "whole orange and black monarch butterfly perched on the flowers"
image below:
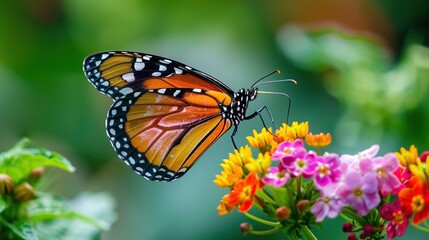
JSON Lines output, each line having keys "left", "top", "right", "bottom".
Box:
{"left": 83, "top": 51, "right": 290, "bottom": 181}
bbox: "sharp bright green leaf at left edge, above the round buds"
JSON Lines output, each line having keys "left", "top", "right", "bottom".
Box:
{"left": 0, "top": 139, "right": 75, "bottom": 183}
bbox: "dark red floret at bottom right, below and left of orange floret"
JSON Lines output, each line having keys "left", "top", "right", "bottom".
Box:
{"left": 380, "top": 199, "right": 408, "bottom": 239}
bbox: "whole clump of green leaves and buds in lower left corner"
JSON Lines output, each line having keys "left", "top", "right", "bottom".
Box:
{"left": 0, "top": 139, "right": 116, "bottom": 239}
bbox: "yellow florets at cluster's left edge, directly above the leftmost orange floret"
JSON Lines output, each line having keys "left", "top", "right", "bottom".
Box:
{"left": 213, "top": 145, "right": 252, "bottom": 188}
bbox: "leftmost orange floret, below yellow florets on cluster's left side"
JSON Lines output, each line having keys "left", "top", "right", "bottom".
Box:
{"left": 228, "top": 172, "right": 259, "bottom": 212}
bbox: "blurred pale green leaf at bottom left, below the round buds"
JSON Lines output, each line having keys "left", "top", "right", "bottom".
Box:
{"left": 20, "top": 192, "right": 116, "bottom": 239}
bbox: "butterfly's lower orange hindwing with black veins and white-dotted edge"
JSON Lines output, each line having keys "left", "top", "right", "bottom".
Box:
{"left": 106, "top": 89, "right": 231, "bottom": 181}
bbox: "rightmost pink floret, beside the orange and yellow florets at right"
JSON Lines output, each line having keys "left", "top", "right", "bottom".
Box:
{"left": 359, "top": 153, "right": 401, "bottom": 194}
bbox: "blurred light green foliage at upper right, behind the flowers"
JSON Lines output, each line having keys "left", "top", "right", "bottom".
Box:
{"left": 280, "top": 27, "right": 429, "bottom": 146}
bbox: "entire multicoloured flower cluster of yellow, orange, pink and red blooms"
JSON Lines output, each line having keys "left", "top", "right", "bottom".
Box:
{"left": 214, "top": 122, "right": 429, "bottom": 239}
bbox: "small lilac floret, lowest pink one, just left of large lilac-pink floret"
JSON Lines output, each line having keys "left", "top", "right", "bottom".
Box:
{"left": 310, "top": 184, "right": 344, "bottom": 222}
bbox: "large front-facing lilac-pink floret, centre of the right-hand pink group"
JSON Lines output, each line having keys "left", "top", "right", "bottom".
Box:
{"left": 337, "top": 171, "right": 380, "bottom": 216}
